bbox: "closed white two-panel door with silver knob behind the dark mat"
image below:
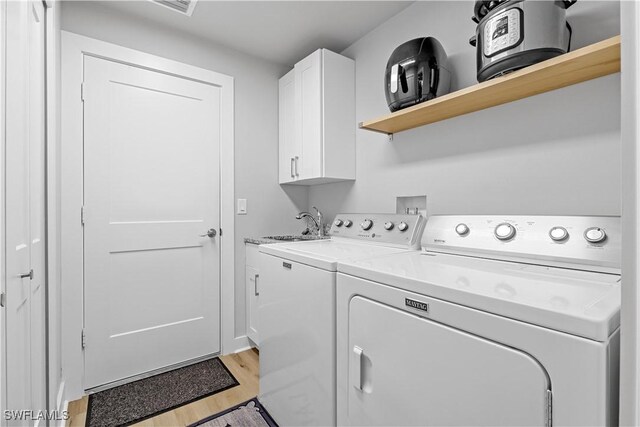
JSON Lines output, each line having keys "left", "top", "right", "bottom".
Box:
{"left": 84, "top": 56, "right": 220, "bottom": 388}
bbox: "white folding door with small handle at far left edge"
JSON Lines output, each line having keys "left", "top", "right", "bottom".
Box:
{"left": 5, "top": 0, "right": 46, "bottom": 424}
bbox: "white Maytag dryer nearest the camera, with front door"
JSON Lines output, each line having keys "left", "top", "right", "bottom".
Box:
{"left": 336, "top": 216, "right": 621, "bottom": 426}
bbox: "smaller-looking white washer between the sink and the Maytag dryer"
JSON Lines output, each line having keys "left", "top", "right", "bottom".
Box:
{"left": 259, "top": 214, "right": 424, "bottom": 426}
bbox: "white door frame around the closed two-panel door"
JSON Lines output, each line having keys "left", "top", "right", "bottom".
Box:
{"left": 59, "top": 31, "right": 236, "bottom": 400}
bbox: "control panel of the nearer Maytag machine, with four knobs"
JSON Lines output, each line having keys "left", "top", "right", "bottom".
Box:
{"left": 422, "top": 215, "right": 621, "bottom": 272}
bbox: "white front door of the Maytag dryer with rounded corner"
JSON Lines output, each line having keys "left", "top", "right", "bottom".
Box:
{"left": 347, "top": 297, "right": 550, "bottom": 426}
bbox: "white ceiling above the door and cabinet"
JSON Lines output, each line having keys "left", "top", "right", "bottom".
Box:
{"left": 95, "top": 0, "right": 413, "bottom": 66}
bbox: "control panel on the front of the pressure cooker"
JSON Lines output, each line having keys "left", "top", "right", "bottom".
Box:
{"left": 482, "top": 7, "right": 523, "bottom": 57}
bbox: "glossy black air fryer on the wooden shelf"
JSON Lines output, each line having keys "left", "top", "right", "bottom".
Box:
{"left": 385, "top": 37, "right": 451, "bottom": 112}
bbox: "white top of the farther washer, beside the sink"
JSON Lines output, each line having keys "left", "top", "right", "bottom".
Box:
{"left": 260, "top": 238, "right": 419, "bottom": 271}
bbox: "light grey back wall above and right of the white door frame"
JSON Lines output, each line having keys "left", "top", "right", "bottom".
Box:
{"left": 62, "top": 1, "right": 308, "bottom": 344}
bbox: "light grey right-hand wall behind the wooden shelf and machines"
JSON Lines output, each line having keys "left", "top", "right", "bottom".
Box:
{"left": 309, "top": 1, "right": 620, "bottom": 224}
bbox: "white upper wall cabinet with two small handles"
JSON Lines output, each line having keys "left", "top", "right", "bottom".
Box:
{"left": 279, "top": 49, "right": 356, "bottom": 185}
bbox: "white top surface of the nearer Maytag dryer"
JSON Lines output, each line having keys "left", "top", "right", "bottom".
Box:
{"left": 338, "top": 252, "right": 620, "bottom": 341}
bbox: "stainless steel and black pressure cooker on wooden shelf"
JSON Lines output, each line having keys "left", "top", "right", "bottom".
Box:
{"left": 469, "top": 0, "right": 577, "bottom": 82}
